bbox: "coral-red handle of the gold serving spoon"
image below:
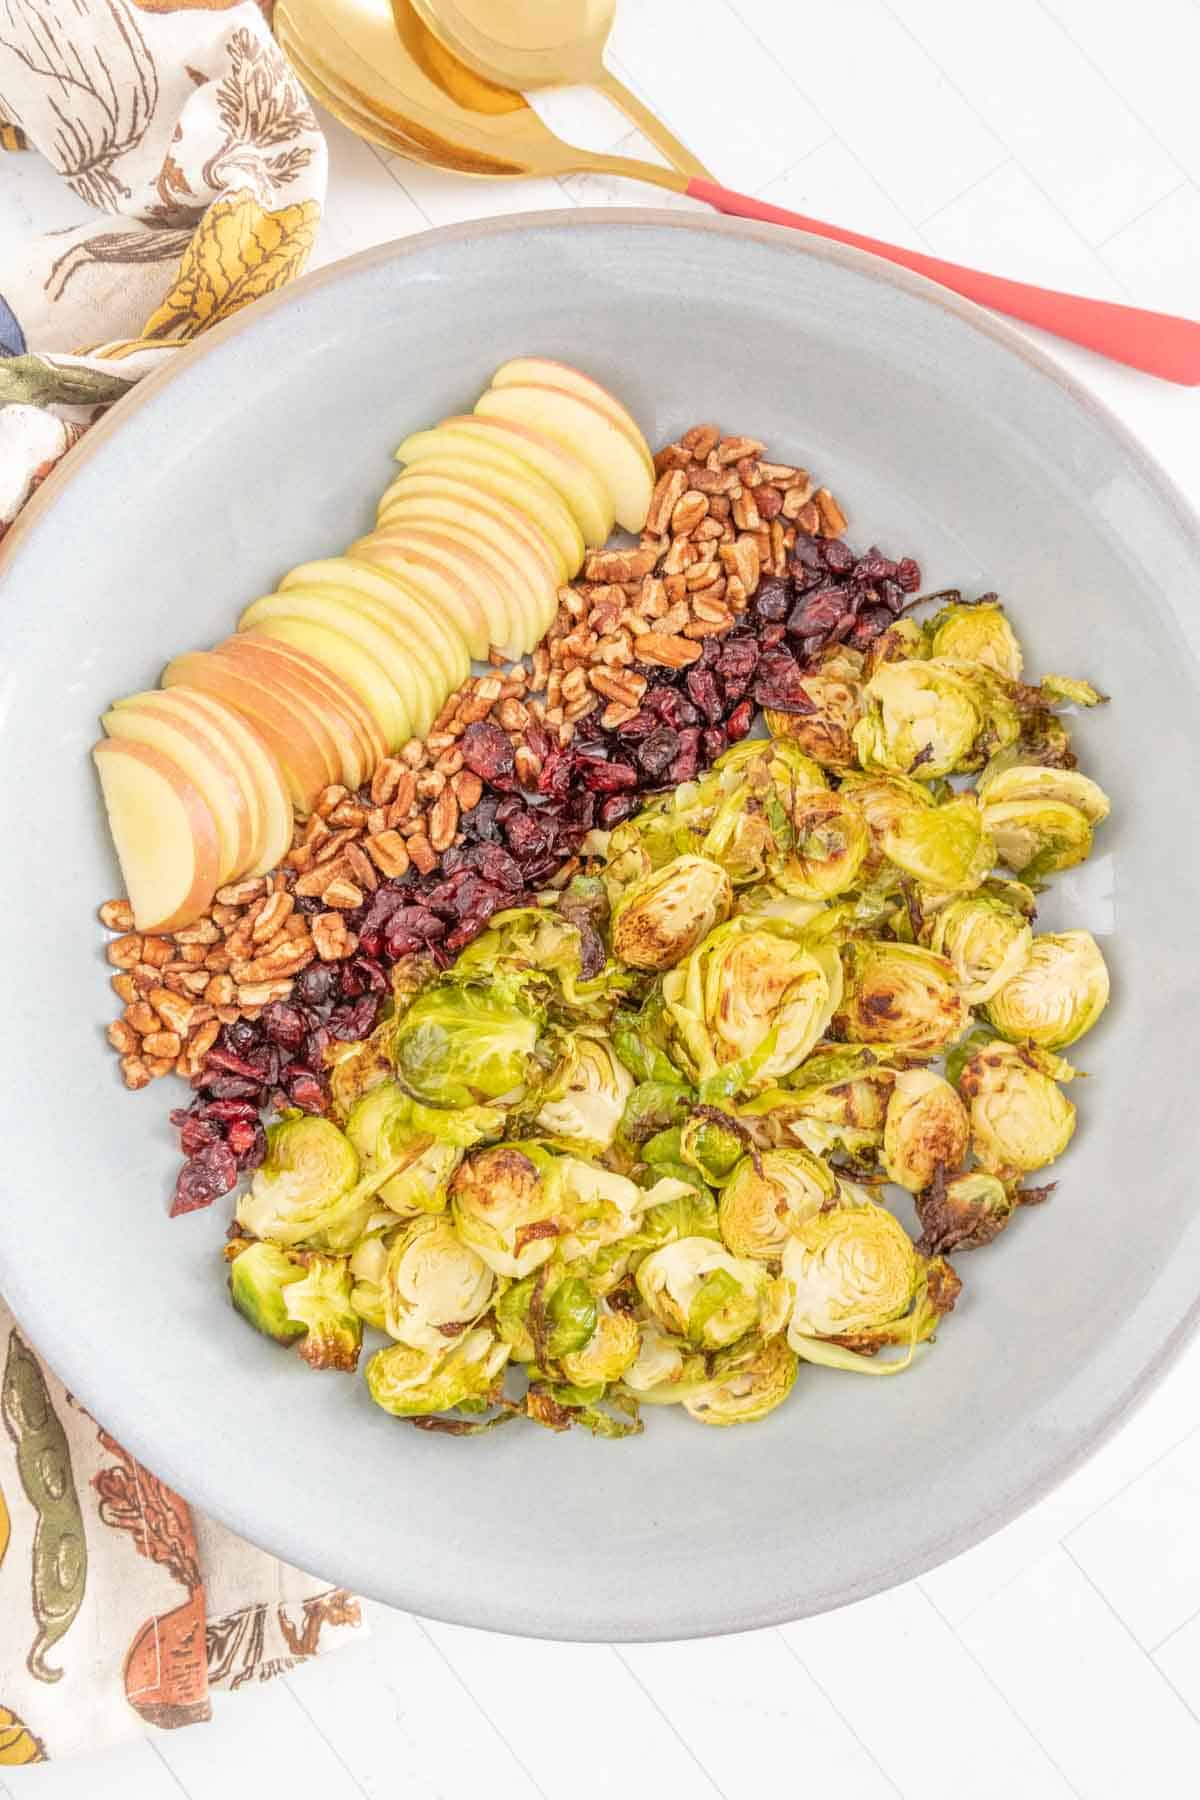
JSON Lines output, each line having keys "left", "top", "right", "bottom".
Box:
{"left": 687, "top": 176, "right": 1200, "bottom": 387}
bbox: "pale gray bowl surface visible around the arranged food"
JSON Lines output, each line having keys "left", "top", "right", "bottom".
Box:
{"left": 0, "top": 212, "right": 1200, "bottom": 1640}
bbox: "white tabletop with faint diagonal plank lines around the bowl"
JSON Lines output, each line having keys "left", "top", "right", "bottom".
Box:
{"left": 0, "top": 0, "right": 1200, "bottom": 1800}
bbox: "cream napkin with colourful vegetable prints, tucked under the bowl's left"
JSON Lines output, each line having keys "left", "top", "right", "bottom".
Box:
{"left": 0, "top": 0, "right": 367, "bottom": 1756}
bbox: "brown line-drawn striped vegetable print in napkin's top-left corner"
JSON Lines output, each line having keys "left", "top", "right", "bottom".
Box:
{"left": 0, "top": 0, "right": 158, "bottom": 212}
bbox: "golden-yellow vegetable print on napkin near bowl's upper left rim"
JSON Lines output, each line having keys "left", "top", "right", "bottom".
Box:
{"left": 142, "top": 191, "right": 320, "bottom": 342}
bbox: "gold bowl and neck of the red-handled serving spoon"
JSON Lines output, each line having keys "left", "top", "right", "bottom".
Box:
{"left": 275, "top": 0, "right": 687, "bottom": 193}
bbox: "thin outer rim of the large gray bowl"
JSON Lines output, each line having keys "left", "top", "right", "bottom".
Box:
{"left": 0, "top": 207, "right": 1200, "bottom": 1643}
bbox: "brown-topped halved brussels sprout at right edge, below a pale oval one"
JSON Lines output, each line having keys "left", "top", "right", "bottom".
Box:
{"left": 959, "top": 1044, "right": 1076, "bottom": 1181}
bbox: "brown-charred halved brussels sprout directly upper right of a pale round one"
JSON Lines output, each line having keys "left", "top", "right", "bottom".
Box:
{"left": 450, "top": 1143, "right": 563, "bottom": 1282}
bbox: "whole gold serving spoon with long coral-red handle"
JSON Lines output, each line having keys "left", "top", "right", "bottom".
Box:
{"left": 275, "top": 0, "right": 1200, "bottom": 387}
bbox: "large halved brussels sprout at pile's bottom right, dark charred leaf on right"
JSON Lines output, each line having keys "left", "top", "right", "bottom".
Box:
{"left": 783, "top": 1199, "right": 959, "bottom": 1375}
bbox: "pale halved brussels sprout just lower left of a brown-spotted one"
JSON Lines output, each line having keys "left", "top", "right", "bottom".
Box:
{"left": 381, "top": 1217, "right": 497, "bottom": 1350}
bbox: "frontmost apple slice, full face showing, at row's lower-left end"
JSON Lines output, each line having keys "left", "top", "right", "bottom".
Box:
{"left": 92, "top": 738, "right": 221, "bottom": 932}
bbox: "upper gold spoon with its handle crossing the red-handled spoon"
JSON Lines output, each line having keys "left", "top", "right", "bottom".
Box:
{"left": 412, "top": 0, "right": 711, "bottom": 180}
